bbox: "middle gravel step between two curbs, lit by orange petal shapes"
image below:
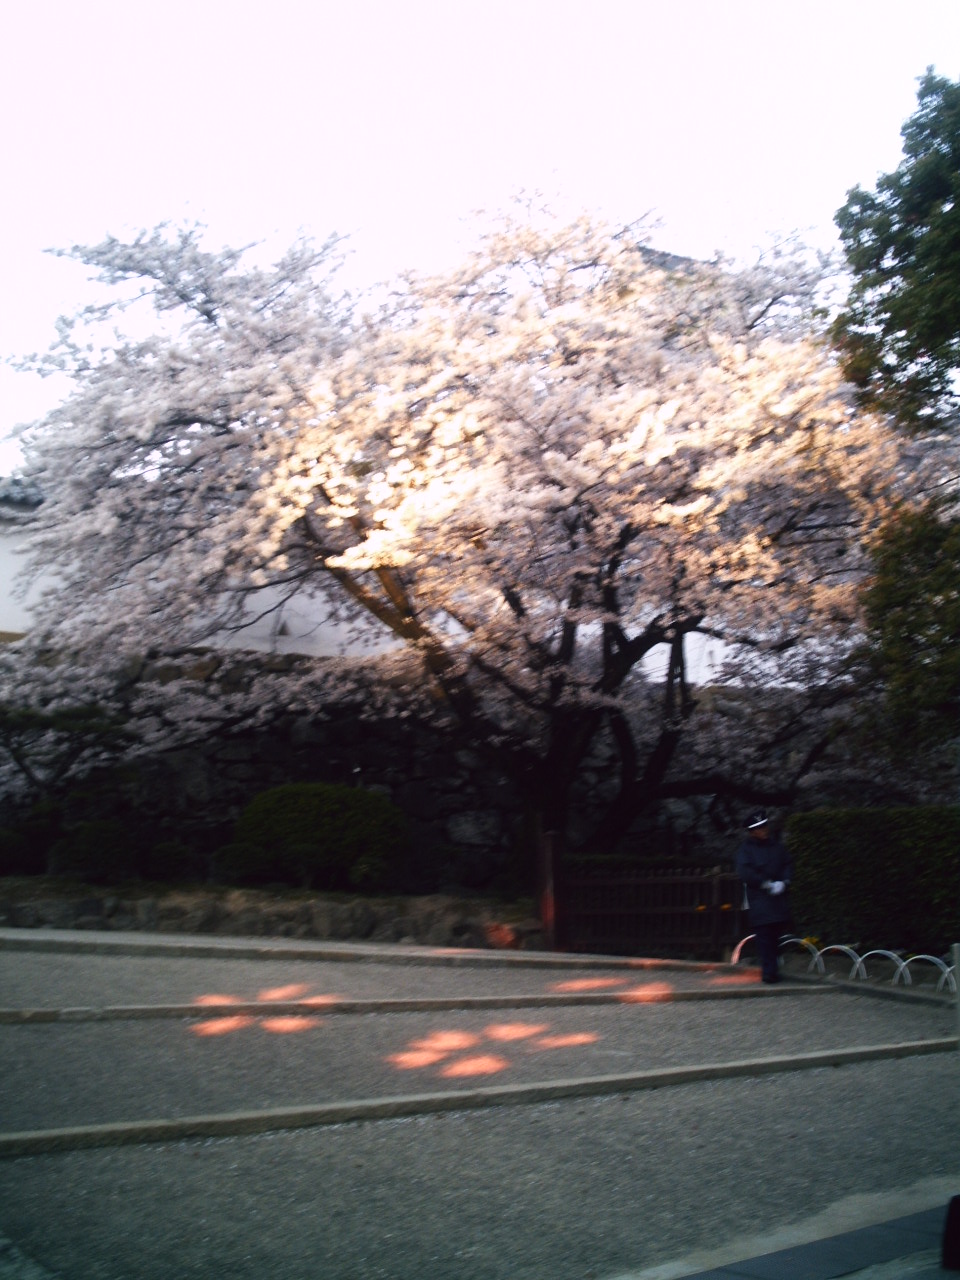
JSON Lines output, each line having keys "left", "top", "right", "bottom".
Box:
{"left": 0, "top": 992, "right": 954, "bottom": 1130}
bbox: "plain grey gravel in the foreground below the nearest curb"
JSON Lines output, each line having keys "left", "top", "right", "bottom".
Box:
{"left": 0, "top": 1056, "right": 960, "bottom": 1280}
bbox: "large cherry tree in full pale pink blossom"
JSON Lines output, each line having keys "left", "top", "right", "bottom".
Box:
{"left": 9, "top": 218, "right": 957, "bottom": 865}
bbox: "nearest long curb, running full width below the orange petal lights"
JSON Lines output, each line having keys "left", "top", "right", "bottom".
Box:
{"left": 0, "top": 1037, "right": 960, "bottom": 1158}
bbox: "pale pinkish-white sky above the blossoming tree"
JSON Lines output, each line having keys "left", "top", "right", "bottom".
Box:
{"left": 0, "top": 0, "right": 960, "bottom": 472}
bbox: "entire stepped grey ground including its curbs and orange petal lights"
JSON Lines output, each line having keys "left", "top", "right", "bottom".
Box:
{"left": 0, "top": 929, "right": 960, "bottom": 1280}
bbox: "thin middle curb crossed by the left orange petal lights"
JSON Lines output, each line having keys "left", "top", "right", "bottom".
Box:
{"left": 0, "top": 984, "right": 833, "bottom": 1025}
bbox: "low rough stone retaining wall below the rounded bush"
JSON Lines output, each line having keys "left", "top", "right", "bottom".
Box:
{"left": 0, "top": 879, "right": 543, "bottom": 950}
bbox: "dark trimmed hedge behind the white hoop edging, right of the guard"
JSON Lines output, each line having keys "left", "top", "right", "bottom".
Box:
{"left": 786, "top": 805, "right": 960, "bottom": 956}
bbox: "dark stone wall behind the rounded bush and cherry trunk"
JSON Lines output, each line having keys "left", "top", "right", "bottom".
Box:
{"left": 0, "top": 649, "right": 731, "bottom": 893}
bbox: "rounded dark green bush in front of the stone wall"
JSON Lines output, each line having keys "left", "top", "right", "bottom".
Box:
{"left": 226, "top": 782, "right": 410, "bottom": 892}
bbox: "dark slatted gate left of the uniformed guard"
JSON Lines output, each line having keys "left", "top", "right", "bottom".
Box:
{"left": 557, "top": 863, "right": 744, "bottom": 960}
